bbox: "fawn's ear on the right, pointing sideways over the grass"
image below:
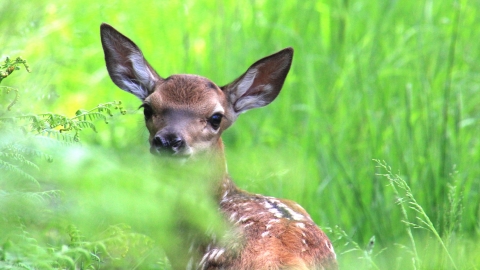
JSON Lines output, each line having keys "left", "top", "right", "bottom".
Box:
{"left": 221, "top": 48, "right": 293, "bottom": 114}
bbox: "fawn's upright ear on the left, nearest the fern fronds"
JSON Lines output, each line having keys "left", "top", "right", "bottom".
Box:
{"left": 100, "top": 23, "right": 163, "bottom": 100}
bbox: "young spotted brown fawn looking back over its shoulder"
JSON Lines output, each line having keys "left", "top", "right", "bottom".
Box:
{"left": 100, "top": 23, "right": 338, "bottom": 269}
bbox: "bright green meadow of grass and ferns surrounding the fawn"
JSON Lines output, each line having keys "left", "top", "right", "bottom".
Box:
{"left": 0, "top": 0, "right": 480, "bottom": 269}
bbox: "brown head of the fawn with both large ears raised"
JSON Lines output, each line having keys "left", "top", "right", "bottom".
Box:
{"left": 101, "top": 24, "right": 293, "bottom": 161}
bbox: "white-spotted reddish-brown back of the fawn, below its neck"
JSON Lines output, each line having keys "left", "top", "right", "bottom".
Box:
{"left": 202, "top": 190, "right": 337, "bottom": 269}
